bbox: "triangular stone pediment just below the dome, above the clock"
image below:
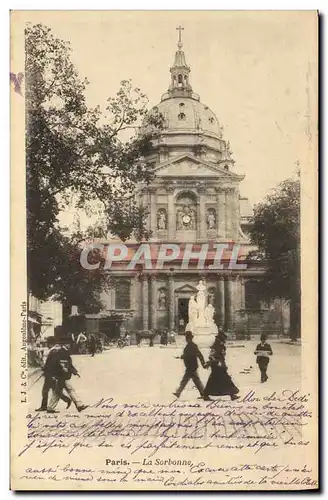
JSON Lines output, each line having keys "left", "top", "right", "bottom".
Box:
{"left": 155, "top": 155, "right": 239, "bottom": 179}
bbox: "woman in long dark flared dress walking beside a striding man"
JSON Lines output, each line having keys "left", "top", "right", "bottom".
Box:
{"left": 204, "top": 332, "right": 239, "bottom": 401}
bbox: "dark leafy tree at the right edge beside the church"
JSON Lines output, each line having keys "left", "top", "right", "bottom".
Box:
{"left": 250, "top": 177, "right": 301, "bottom": 340}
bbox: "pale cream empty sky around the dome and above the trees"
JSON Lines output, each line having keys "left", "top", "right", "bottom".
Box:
{"left": 16, "top": 11, "right": 317, "bottom": 204}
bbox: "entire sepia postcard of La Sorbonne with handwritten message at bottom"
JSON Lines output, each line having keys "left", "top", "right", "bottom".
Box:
{"left": 10, "top": 11, "right": 319, "bottom": 491}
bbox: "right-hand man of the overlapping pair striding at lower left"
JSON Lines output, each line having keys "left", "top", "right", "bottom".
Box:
{"left": 47, "top": 344, "right": 88, "bottom": 413}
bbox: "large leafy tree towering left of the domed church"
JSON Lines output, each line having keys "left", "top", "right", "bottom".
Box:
{"left": 25, "top": 24, "right": 162, "bottom": 306}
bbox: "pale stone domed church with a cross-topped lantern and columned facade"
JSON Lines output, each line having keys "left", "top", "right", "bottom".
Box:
{"left": 88, "top": 27, "right": 283, "bottom": 340}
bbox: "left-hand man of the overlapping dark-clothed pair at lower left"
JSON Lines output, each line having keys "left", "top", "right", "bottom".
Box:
{"left": 35, "top": 337, "right": 72, "bottom": 411}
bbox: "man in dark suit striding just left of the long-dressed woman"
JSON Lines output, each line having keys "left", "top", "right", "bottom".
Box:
{"left": 173, "top": 331, "right": 205, "bottom": 398}
